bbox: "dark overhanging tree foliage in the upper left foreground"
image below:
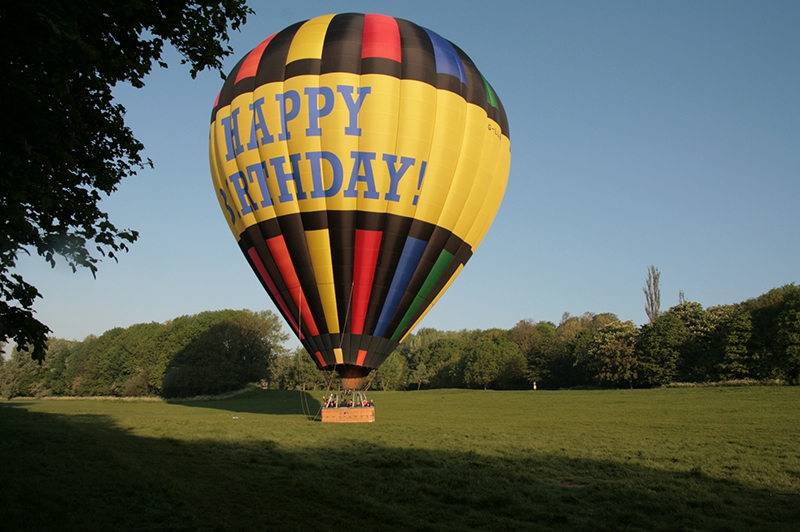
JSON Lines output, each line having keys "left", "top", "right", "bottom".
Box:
{"left": 0, "top": 0, "right": 252, "bottom": 360}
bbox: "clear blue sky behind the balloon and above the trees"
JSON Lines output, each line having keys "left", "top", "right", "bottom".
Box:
{"left": 14, "top": 0, "right": 800, "bottom": 344}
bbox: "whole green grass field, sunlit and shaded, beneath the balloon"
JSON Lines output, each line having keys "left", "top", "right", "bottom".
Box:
{"left": 0, "top": 387, "right": 800, "bottom": 532}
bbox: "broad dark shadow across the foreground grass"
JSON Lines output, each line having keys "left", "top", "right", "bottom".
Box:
{"left": 0, "top": 403, "right": 800, "bottom": 532}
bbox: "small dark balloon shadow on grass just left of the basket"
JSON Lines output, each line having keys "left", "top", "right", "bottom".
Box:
{"left": 170, "top": 389, "right": 324, "bottom": 417}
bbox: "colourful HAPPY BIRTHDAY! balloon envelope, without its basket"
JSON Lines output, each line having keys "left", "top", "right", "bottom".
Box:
{"left": 210, "top": 13, "right": 510, "bottom": 389}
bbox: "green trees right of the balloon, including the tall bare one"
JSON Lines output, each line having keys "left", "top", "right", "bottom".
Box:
{"left": 334, "top": 282, "right": 800, "bottom": 389}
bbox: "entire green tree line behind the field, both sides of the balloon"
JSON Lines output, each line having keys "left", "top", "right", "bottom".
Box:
{"left": 0, "top": 284, "right": 800, "bottom": 397}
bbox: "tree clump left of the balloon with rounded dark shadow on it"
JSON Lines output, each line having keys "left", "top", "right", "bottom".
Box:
{"left": 0, "top": 310, "right": 288, "bottom": 397}
